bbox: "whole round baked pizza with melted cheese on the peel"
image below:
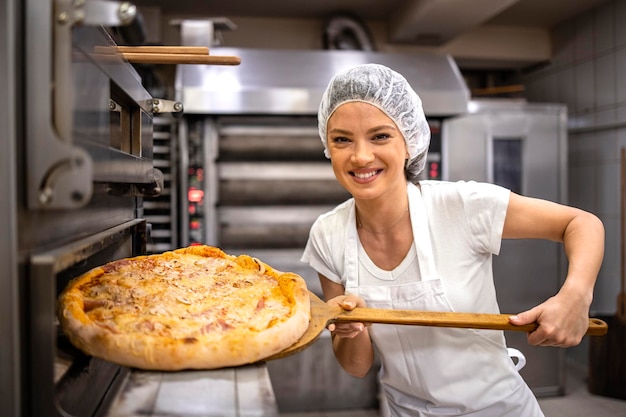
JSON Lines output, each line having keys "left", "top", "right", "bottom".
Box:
{"left": 58, "top": 246, "right": 310, "bottom": 370}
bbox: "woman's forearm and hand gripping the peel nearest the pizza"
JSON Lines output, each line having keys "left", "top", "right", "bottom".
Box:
{"left": 319, "top": 274, "right": 374, "bottom": 378}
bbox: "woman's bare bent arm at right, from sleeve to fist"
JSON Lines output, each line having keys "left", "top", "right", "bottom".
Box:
{"left": 503, "top": 193, "right": 604, "bottom": 347}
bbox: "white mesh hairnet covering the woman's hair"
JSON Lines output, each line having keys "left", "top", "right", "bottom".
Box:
{"left": 317, "top": 64, "right": 430, "bottom": 178}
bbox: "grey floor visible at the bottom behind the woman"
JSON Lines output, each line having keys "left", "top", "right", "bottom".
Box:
{"left": 280, "top": 360, "right": 626, "bottom": 417}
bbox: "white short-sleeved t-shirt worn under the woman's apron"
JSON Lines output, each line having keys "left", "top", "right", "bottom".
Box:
{"left": 301, "top": 181, "right": 510, "bottom": 313}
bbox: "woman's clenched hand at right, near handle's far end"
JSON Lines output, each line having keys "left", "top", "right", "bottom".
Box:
{"left": 509, "top": 288, "right": 591, "bottom": 347}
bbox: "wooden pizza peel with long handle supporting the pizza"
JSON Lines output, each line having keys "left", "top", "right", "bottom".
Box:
{"left": 264, "top": 291, "right": 608, "bottom": 360}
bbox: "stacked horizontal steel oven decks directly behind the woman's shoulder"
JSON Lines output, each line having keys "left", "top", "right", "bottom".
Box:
{"left": 181, "top": 116, "right": 349, "bottom": 266}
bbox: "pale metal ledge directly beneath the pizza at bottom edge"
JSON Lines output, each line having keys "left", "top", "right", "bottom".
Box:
{"left": 105, "top": 363, "right": 279, "bottom": 417}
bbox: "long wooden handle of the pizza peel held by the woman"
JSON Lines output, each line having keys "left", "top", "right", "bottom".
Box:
{"left": 330, "top": 308, "right": 608, "bottom": 336}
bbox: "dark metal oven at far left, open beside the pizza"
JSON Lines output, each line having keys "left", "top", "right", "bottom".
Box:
{"left": 0, "top": 0, "right": 190, "bottom": 417}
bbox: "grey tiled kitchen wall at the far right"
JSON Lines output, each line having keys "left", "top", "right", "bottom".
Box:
{"left": 524, "top": 0, "right": 626, "bottom": 362}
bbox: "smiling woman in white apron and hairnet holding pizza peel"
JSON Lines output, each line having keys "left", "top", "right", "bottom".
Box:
{"left": 302, "top": 64, "right": 604, "bottom": 417}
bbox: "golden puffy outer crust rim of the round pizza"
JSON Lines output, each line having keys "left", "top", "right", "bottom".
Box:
{"left": 58, "top": 246, "right": 310, "bottom": 371}
